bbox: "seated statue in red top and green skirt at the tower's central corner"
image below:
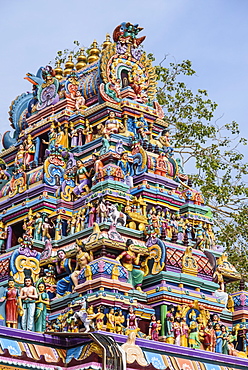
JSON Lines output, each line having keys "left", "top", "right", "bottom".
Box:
{"left": 116, "top": 239, "right": 144, "bottom": 291}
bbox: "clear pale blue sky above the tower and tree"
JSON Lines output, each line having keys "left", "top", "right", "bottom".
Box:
{"left": 0, "top": 0, "right": 248, "bottom": 158}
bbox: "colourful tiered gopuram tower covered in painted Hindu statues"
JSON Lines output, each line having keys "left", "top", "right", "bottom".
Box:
{"left": 0, "top": 23, "right": 248, "bottom": 370}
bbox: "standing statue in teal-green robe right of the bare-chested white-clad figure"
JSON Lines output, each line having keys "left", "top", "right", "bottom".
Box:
{"left": 34, "top": 281, "right": 49, "bottom": 333}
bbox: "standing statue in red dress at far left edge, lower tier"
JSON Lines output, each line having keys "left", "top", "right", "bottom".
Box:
{"left": 0, "top": 278, "right": 22, "bottom": 329}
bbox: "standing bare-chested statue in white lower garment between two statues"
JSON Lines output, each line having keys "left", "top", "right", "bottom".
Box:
{"left": 20, "top": 276, "right": 38, "bottom": 331}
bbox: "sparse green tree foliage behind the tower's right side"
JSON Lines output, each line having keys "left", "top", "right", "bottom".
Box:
{"left": 155, "top": 55, "right": 248, "bottom": 290}
